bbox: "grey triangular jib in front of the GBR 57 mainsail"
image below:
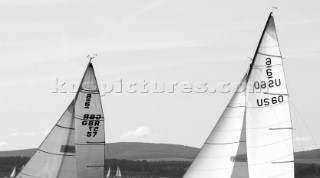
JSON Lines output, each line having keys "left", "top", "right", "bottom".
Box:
{"left": 17, "top": 102, "right": 77, "bottom": 178}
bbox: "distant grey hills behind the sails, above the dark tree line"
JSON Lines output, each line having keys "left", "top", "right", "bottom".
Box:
{"left": 0, "top": 142, "right": 320, "bottom": 165}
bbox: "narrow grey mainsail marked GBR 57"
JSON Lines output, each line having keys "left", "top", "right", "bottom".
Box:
{"left": 74, "top": 63, "right": 105, "bottom": 178}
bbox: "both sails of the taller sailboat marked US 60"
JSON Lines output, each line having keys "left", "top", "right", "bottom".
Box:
{"left": 184, "top": 12, "right": 294, "bottom": 178}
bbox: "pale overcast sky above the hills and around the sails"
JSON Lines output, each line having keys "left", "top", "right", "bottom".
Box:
{"left": 0, "top": 0, "right": 320, "bottom": 153}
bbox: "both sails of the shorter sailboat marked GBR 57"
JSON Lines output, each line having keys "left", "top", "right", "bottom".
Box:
{"left": 17, "top": 61, "right": 105, "bottom": 178}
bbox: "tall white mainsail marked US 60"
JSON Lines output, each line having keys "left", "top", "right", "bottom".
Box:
{"left": 246, "top": 14, "right": 294, "bottom": 178}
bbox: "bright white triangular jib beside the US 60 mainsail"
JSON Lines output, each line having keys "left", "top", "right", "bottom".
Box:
{"left": 184, "top": 75, "right": 248, "bottom": 178}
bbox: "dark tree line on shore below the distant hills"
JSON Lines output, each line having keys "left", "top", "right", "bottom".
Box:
{"left": 0, "top": 157, "right": 320, "bottom": 178}
